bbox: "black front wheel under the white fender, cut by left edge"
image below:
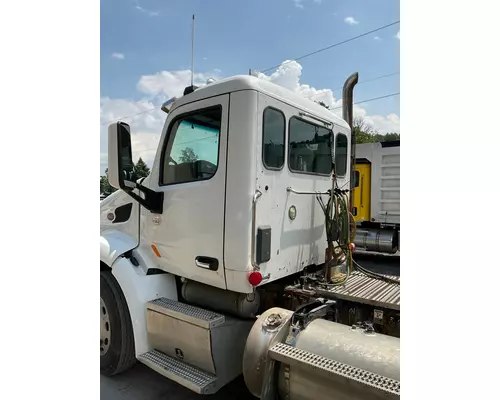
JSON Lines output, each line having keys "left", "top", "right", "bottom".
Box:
{"left": 100, "top": 271, "right": 136, "bottom": 376}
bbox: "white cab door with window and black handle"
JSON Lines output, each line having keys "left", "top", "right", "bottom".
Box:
{"left": 141, "top": 94, "right": 229, "bottom": 288}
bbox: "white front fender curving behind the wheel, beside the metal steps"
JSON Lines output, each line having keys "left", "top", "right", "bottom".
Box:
{"left": 110, "top": 256, "right": 177, "bottom": 357}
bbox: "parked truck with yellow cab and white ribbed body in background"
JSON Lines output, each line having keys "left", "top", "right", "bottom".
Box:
{"left": 353, "top": 140, "right": 400, "bottom": 255}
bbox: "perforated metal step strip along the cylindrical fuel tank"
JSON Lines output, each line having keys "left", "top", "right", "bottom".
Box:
{"left": 269, "top": 343, "right": 400, "bottom": 397}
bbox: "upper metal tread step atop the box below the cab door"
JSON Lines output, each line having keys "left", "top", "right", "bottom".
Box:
{"left": 147, "top": 297, "right": 226, "bottom": 329}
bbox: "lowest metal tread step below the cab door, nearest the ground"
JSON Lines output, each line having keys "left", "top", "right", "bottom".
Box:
{"left": 138, "top": 350, "right": 219, "bottom": 394}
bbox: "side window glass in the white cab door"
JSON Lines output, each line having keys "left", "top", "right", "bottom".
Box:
{"left": 160, "top": 106, "right": 222, "bottom": 185}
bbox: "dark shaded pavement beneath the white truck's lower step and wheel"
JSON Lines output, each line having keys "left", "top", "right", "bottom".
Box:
{"left": 101, "top": 363, "right": 256, "bottom": 400}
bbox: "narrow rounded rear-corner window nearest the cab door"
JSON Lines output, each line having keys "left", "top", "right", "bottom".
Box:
{"left": 262, "top": 107, "right": 285, "bottom": 169}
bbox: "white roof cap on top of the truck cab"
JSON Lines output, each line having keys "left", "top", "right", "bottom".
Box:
{"left": 174, "top": 75, "right": 349, "bottom": 129}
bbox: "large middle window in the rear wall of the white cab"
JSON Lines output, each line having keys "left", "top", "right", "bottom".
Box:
{"left": 288, "top": 117, "right": 332, "bottom": 175}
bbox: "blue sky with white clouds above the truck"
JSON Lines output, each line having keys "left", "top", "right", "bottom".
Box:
{"left": 100, "top": 0, "right": 400, "bottom": 173}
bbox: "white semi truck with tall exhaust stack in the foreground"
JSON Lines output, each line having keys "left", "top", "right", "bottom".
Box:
{"left": 100, "top": 73, "right": 400, "bottom": 400}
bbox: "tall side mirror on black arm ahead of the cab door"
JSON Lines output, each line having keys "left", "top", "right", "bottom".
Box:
{"left": 108, "top": 122, "right": 134, "bottom": 190}
